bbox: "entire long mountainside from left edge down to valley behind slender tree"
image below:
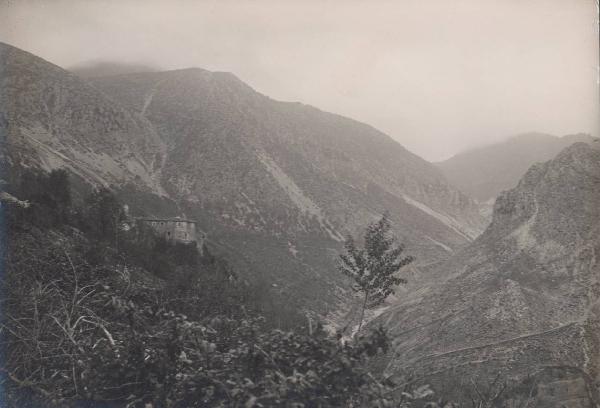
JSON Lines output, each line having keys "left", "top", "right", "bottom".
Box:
{"left": 0, "top": 45, "right": 485, "bottom": 312}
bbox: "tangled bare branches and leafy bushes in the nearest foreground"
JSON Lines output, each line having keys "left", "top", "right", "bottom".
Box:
{"left": 2, "top": 231, "right": 398, "bottom": 407}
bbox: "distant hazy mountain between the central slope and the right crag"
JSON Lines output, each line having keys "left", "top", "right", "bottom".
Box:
{"left": 436, "top": 133, "right": 593, "bottom": 202}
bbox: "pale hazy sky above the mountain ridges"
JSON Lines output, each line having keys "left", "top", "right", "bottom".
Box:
{"left": 0, "top": 0, "right": 600, "bottom": 160}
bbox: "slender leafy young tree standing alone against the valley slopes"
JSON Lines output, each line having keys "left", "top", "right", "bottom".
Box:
{"left": 339, "top": 214, "right": 413, "bottom": 334}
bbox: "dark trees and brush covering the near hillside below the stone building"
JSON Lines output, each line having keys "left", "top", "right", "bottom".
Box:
{"left": 0, "top": 168, "right": 440, "bottom": 407}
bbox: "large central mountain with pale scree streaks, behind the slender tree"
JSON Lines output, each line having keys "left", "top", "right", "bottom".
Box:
{"left": 93, "top": 69, "right": 485, "bottom": 321}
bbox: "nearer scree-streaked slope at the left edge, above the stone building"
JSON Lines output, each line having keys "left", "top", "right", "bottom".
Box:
{"left": 0, "top": 43, "right": 164, "bottom": 194}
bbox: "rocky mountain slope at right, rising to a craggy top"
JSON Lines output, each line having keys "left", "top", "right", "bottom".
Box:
{"left": 377, "top": 142, "right": 600, "bottom": 407}
